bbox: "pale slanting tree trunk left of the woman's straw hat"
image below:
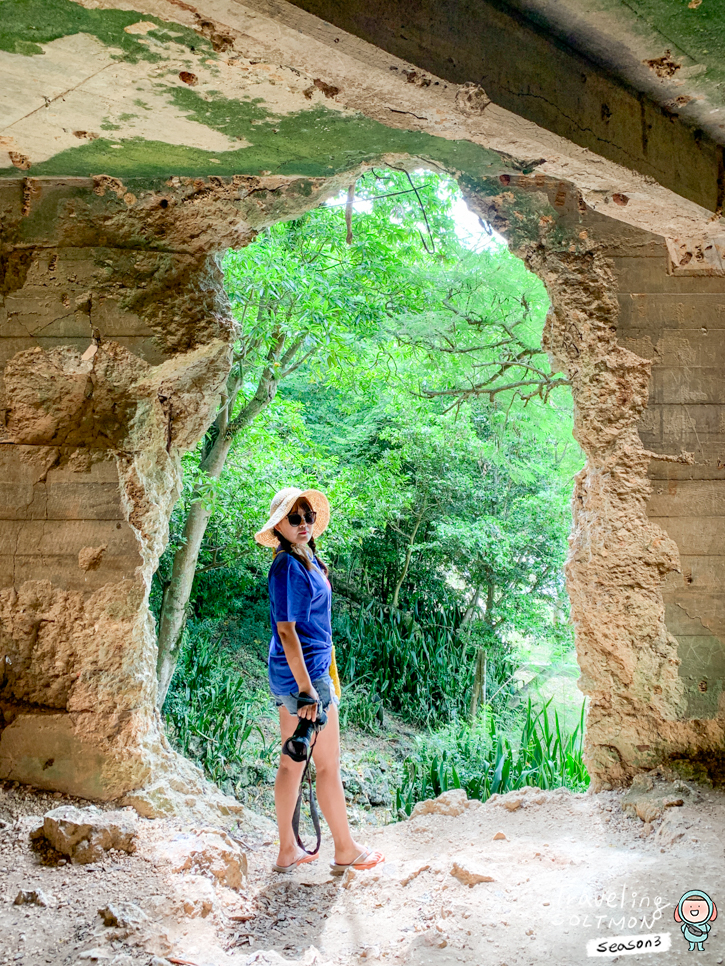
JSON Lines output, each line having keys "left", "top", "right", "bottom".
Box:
{"left": 156, "top": 334, "right": 286, "bottom": 708}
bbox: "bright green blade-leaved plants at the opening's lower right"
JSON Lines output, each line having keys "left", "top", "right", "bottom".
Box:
{"left": 395, "top": 701, "right": 589, "bottom": 818}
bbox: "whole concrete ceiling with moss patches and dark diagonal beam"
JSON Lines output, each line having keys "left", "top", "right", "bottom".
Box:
{"left": 0, "top": 0, "right": 725, "bottom": 238}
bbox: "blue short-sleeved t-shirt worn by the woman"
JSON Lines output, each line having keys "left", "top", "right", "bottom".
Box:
{"left": 268, "top": 552, "right": 332, "bottom": 694}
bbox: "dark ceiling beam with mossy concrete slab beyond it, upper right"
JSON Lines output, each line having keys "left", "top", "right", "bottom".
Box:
{"left": 292, "top": 0, "right": 725, "bottom": 211}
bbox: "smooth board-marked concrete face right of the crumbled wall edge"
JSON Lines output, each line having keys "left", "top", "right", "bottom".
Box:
{"left": 613, "top": 239, "right": 725, "bottom": 764}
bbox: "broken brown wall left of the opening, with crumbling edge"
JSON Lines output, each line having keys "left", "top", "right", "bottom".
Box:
{"left": 0, "top": 170, "right": 335, "bottom": 799}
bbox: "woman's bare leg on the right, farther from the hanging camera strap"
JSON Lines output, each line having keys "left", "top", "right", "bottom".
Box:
{"left": 312, "top": 704, "right": 363, "bottom": 863}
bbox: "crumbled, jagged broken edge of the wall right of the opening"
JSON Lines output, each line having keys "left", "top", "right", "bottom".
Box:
{"left": 530, "top": 213, "right": 682, "bottom": 788}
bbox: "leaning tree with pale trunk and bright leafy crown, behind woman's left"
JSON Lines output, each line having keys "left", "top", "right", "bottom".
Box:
{"left": 157, "top": 176, "right": 466, "bottom": 705}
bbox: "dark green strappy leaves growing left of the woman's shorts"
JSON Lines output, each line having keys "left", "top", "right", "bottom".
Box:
{"left": 164, "top": 621, "right": 274, "bottom": 785}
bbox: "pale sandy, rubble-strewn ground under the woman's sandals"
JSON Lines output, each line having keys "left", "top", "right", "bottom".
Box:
{"left": 0, "top": 786, "right": 725, "bottom": 966}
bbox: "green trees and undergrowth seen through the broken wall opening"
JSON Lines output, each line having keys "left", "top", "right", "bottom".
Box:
{"left": 152, "top": 171, "right": 588, "bottom": 815}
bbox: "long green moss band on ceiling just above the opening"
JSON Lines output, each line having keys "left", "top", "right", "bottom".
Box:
{"left": 0, "top": 104, "right": 502, "bottom": 178}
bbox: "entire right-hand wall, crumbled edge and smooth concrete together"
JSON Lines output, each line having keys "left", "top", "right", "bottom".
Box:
{"left": 471, "top": 178, "right": 725, "bottom": 787}
